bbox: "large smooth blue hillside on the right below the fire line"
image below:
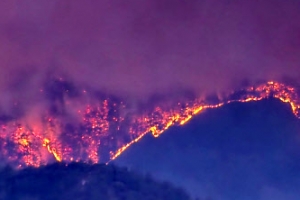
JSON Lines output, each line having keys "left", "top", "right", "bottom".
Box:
{"left": 114, "top": 98, "right": 300, "bottom": 200}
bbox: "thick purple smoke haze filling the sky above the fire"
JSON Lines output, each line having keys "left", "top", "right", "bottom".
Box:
{"left": 0, "top": 0, "right": 300, "bottom": 106}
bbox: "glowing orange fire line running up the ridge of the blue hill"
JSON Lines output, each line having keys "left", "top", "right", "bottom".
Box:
{"left": 111, "top": 81, "right": 300, "bottom": 160}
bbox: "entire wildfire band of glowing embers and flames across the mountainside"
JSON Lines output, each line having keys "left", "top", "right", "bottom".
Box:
{"left": 0, "top": 81, "right": 300, "bottom": 167}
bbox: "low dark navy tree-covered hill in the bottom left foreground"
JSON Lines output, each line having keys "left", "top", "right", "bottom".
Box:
{"left": 0, "top": 163, "right": 190, "bottom": 200}
